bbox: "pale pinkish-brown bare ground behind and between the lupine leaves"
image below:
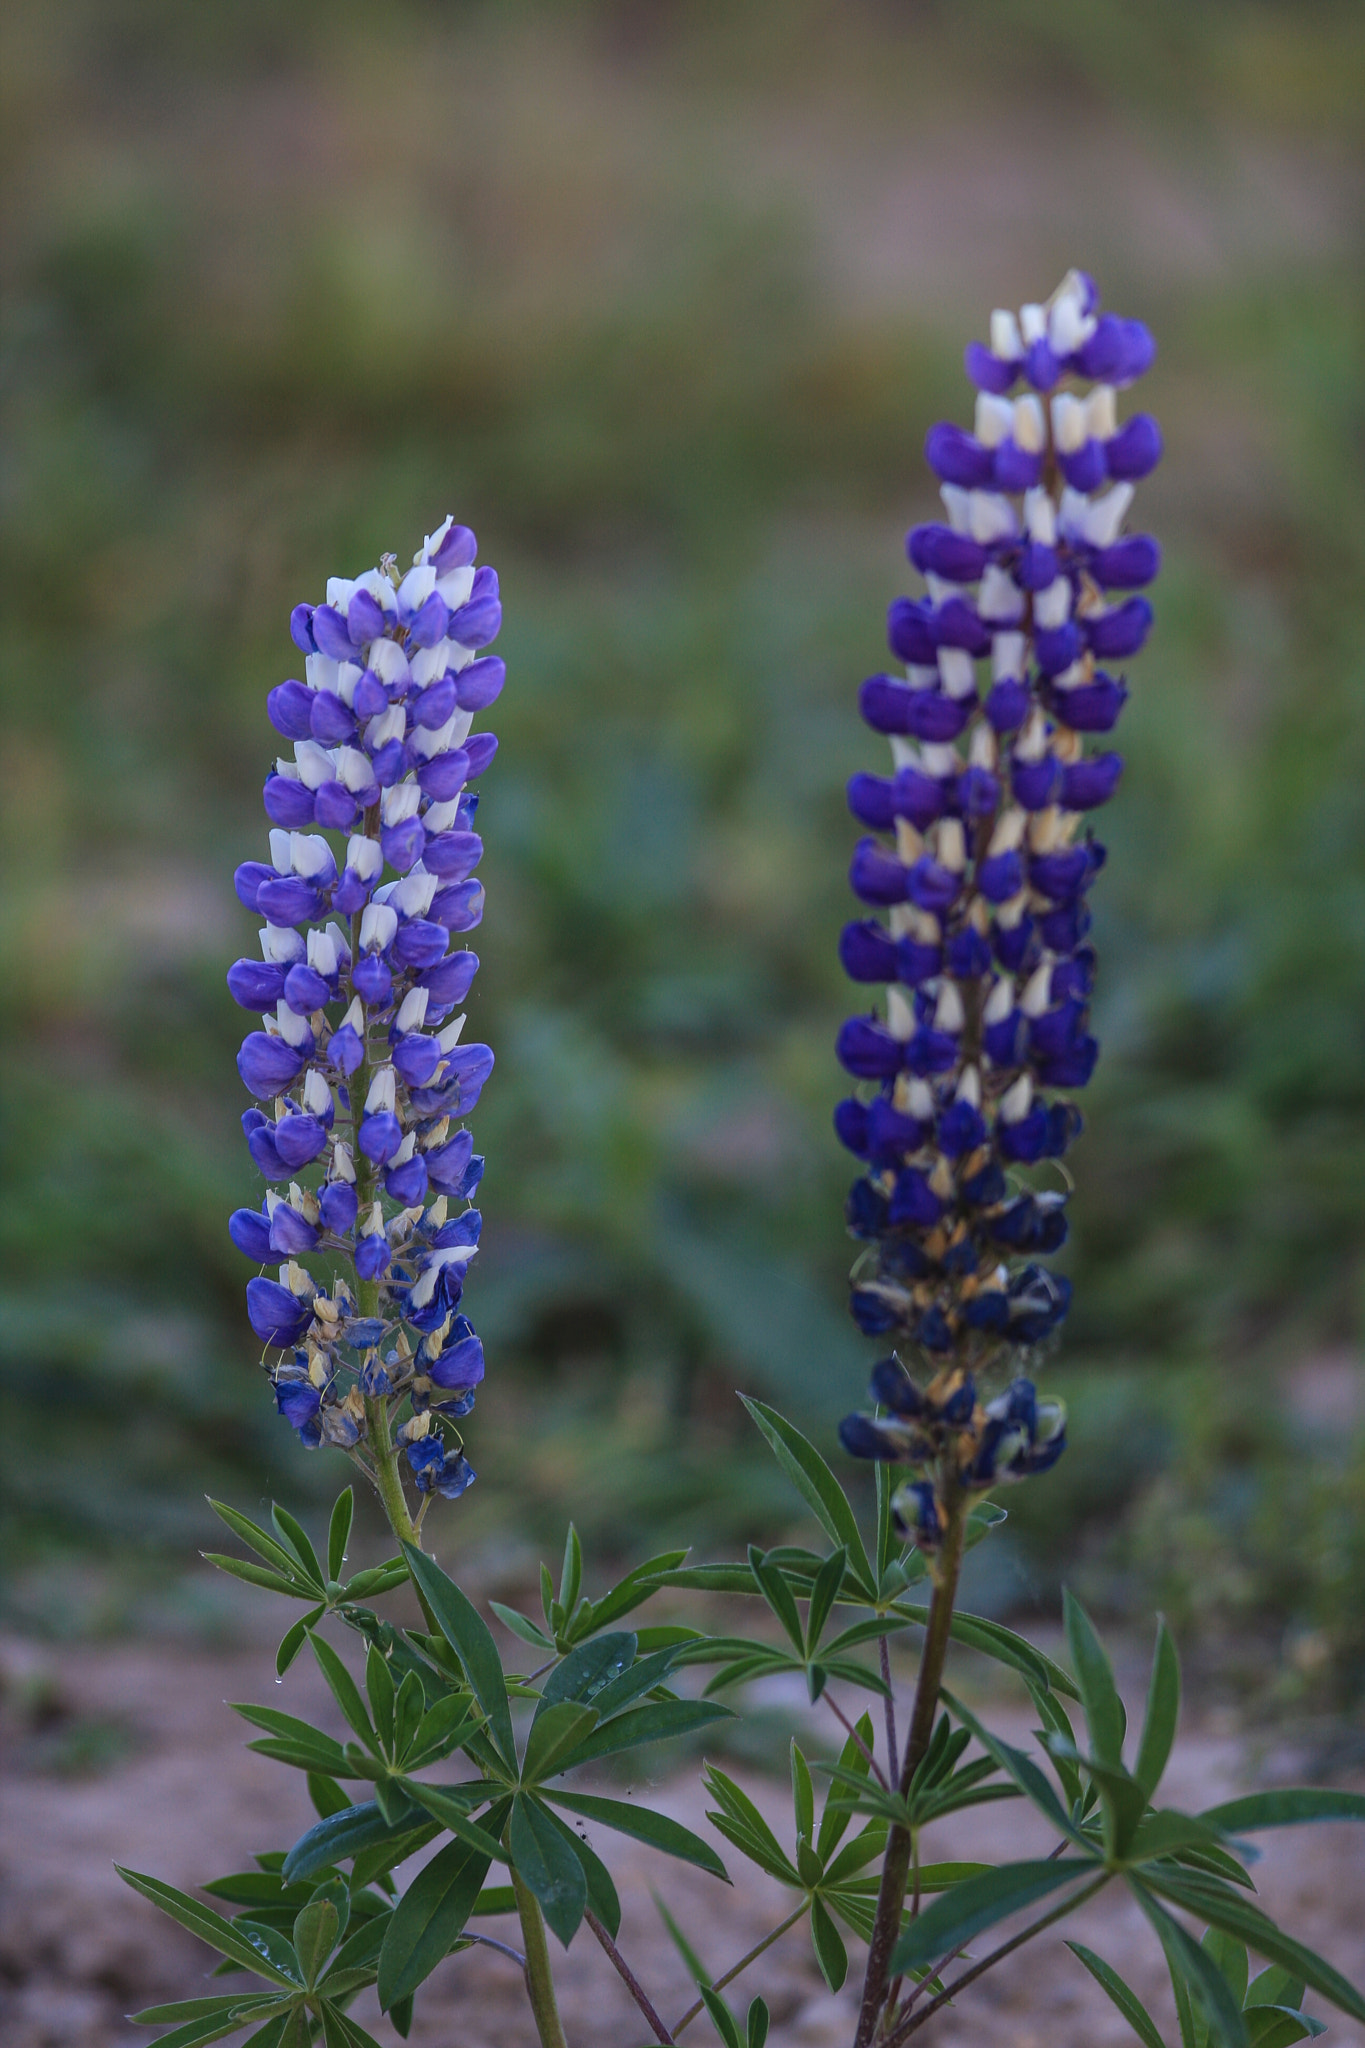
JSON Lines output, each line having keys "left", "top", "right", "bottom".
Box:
{"left": 0, "top": 1642, "right": 1365, "bottom": 2048}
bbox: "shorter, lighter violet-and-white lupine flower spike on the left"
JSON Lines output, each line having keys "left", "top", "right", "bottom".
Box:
{"left": 227, "top": 518, "right": 505, "bottom": 1528}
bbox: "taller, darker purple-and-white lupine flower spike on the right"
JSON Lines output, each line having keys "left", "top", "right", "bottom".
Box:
{"left": 835, "top": 270, "right": 1160, "bottom": 1550}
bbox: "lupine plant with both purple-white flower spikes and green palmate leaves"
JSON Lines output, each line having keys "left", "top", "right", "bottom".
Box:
{"left": 123, "top": 272, "right": 1365, "bottom": 2048}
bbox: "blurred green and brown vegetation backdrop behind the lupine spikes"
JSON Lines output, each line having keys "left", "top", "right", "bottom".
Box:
{"left": 0, "top": 0, "right": 1365, "bottom": 1708}
